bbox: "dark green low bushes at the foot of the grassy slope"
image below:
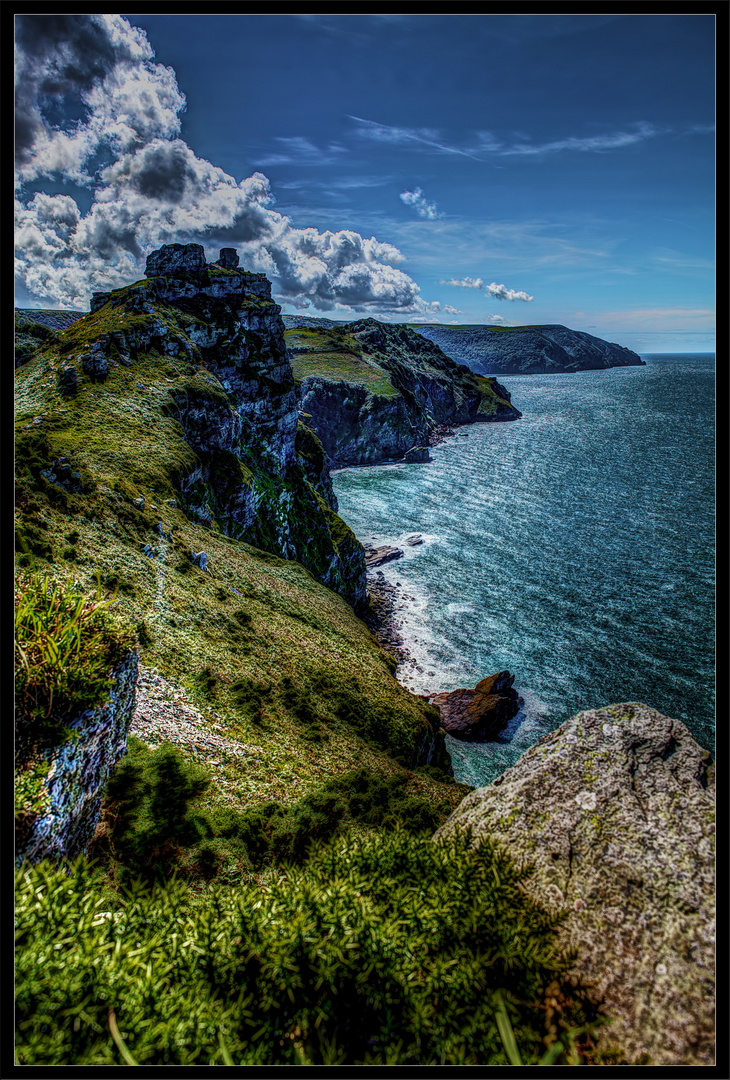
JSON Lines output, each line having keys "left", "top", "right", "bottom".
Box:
{"left": 93, "top": 739, "right": 450, "bottom": 881}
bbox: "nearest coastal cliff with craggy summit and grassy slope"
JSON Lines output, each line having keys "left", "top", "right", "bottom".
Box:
{"left": 15, "top": 245, "right": 448, "bottom": 846}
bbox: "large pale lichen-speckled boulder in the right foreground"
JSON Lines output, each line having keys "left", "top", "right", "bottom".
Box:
{"left": 436, "top": 704, "right": 715, "bottom": 1066}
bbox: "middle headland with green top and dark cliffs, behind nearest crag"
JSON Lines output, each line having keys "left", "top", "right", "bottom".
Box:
{"left": 286, "top": 319, "right": 521, "bottom": 465}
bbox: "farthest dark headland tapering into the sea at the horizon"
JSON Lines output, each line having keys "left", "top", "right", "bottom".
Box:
{"left": 415, "top": 324, "right": 644, "bottom": 375}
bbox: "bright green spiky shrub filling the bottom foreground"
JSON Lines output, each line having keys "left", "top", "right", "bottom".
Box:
{"left": 15, "top": 829, "right": 613, "bottom": 1066}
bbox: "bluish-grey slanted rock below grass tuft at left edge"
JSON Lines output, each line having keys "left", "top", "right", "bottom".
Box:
{"left": 15, "top": 651, "right": 138, "bottom": 863}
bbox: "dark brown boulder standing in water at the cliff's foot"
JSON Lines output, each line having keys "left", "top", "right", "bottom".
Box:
{"left": 431, "top": 672, "right": 522, "bottom": 742}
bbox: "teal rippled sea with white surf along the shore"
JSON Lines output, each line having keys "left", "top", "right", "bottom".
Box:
{"left": 333, "top": 354, "right": 715, "bottom": 786}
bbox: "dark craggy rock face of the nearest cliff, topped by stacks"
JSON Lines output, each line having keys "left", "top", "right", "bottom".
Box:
{"left": 66, "top": 244, "right": 365, "bottom": 605}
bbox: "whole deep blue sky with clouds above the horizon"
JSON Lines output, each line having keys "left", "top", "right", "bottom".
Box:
{"left": 15, "top": 13, "right": 715, "bottom": 352}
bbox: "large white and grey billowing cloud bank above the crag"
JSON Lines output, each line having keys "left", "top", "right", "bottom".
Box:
{"left": 15, "top": 15, "right": 456, "bottom": 316}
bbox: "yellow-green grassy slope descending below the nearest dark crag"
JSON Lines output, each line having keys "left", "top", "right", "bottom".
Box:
{"left": 16, "top": 309, "right": 463, "bottom": 806}
